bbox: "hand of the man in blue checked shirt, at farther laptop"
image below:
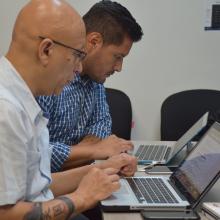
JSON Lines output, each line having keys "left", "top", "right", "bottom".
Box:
{"left": 91, "top": 135, "right": 133, "bottom": 159}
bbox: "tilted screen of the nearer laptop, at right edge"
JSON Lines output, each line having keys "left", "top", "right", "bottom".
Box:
{"left": 171, "top": 123, "right": 220, "bottom": 204}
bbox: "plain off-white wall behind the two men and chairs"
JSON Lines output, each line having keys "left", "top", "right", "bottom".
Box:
{"left": 0, "top": 0, "right": 220, "bottom": 139}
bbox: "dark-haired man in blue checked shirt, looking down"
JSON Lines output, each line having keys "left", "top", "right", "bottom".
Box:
{"left": 37, "top": 1, "right": 143, "bottom": 172}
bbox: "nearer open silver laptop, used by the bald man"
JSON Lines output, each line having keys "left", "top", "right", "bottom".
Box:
{"left": 101, "top": 122, "right": 220, "bottom": 212}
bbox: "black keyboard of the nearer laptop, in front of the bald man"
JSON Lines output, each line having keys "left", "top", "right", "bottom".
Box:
{"left": 126, "top": 177, "right": 179, "bottom": 203}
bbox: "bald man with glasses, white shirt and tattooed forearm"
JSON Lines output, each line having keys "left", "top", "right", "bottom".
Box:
{"left": 0, "top": 0, "right": 136, "bottom": 220}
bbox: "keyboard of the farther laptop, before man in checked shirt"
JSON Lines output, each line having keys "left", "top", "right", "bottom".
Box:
{"left": 135, "top": 145, "right": 171, "bottom": 161}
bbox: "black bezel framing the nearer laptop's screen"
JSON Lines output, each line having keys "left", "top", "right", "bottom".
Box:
{"left": 170, "top": 122, "right": 220, "bottom": 208}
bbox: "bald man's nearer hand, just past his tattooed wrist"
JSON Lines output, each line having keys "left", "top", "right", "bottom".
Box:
{"left": 74, "top": 168, "right": 120, "bottom": 210}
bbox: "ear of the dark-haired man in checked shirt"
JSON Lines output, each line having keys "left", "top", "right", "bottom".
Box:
{"left": 86, "top": 32, "right": 103, "bottom": 51}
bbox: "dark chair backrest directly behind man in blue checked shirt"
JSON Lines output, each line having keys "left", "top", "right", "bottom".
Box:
{"left": 106, "top": 88, "right": 132, "bottom": 140}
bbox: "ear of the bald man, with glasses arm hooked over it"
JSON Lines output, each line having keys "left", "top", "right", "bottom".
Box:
{"left": 38, "top": 38, "right": 54, "bottom": 66}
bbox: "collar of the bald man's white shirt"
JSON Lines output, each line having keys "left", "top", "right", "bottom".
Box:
{"left": 0, "top": 57, "right": 43, "bottom": 122}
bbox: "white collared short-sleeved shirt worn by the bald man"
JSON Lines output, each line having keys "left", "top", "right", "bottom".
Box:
{"left": 0, "top": 57, "right": 53, "bottom": 205}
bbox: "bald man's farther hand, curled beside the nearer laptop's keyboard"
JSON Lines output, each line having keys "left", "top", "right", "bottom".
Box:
{"left": 97, "top": 153, "right": 137, "bottom": 176}
